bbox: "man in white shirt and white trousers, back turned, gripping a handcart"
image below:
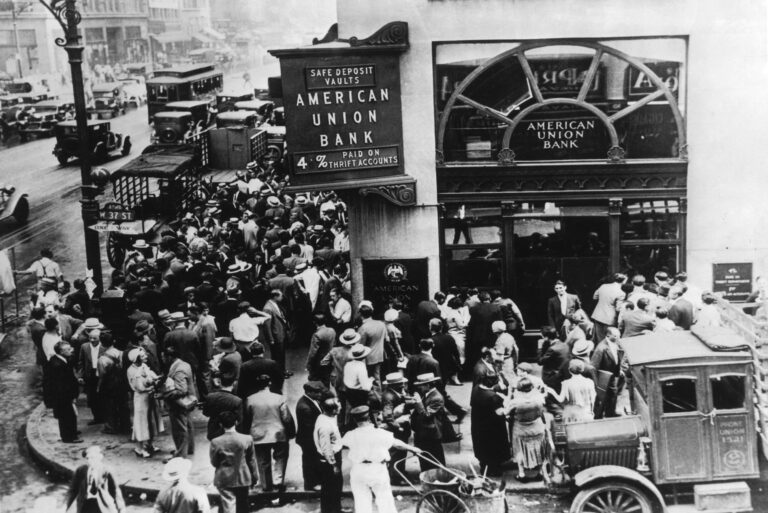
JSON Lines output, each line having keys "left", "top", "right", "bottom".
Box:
{"left": 341, "top": 406, "right": 422, "bottom": 513}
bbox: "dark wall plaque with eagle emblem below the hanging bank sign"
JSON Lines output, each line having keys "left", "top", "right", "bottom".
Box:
{"left": 363, "top": 258, "right": 429, "bottom": 315}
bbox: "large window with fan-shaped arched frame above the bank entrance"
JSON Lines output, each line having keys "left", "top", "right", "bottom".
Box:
{"left": 436, "top": 38, "right": 687, "bottom": 165}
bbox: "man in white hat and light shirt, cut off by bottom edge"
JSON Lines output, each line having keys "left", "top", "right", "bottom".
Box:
{"left": 155, "top": 458, "right": 211, "bottom": 513}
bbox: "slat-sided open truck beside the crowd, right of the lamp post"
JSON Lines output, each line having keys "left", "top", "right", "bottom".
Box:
{"left": 100, "top": 147, "right": 204, "bottom": 268}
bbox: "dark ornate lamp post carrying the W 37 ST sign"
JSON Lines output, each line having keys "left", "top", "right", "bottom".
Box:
{"left": 39, "top": 0, "right": 104, "bottom": 295}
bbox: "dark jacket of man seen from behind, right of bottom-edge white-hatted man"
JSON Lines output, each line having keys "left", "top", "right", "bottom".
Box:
{"left": 209, "top": 433, "right": 256, "bottom": 488}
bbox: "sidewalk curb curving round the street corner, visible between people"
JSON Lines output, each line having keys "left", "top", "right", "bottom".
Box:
{"left": 23, "top": 404, "right": 558, "bottom": 508}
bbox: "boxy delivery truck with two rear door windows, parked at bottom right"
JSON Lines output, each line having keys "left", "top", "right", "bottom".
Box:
{"left": 552, "top": 327, "right": 765, "bottom": 513}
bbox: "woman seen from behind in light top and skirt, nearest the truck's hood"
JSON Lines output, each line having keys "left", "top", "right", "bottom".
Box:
{"left": 508, "top": 378, "right": 547, "bottom": 482}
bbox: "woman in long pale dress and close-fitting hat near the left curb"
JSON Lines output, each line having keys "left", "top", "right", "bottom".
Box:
{"left": 126, "top": 347, "right": 163, "bottom": 458}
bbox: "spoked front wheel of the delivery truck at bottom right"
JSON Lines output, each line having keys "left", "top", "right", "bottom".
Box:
{"left": 570, "top": 481, "right": 655, "bottom": 513}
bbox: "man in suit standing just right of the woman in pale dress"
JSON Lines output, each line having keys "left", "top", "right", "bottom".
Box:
{"left": 164, "top": 346, "right": 195, "bottom": 458}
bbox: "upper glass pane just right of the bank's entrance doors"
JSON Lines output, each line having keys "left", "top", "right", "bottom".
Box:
{"left": 621, "top": 200, "right": 680, "bottom": 240}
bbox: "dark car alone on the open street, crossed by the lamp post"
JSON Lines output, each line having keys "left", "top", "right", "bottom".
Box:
{"left": 53, "top": 120, "right": 131, "bottom": 166}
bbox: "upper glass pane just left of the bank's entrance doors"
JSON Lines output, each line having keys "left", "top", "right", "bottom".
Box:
{"left": 444, "top": 203, "right": 502, "bottom": 245}
